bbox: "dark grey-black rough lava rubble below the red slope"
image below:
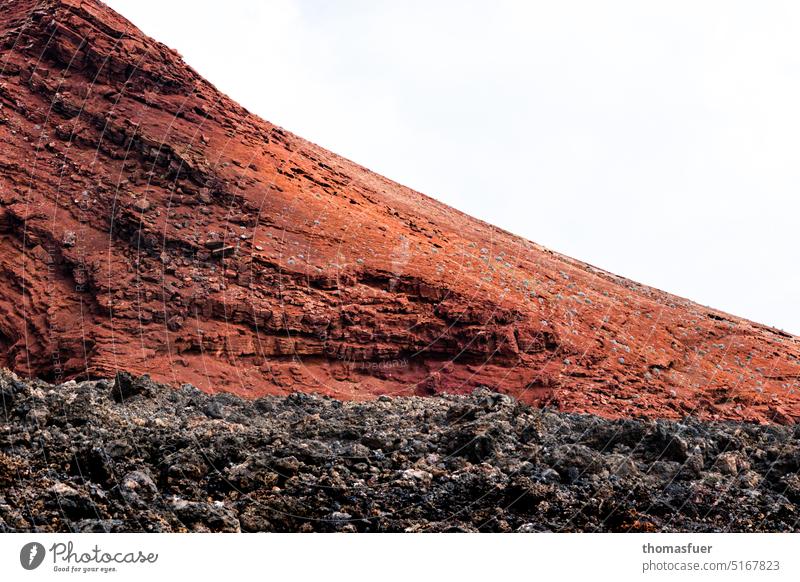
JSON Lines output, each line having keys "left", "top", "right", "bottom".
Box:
{"left": 0, "top": 372, "right": 800, "bottom": 532}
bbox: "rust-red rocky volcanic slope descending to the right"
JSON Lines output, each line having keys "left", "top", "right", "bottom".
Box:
{"left": 0, "top": 0, "right": 800, "bottom": 423}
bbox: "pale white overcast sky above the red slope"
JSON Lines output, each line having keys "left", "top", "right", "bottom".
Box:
{"left": 108, "top": 0, "right": 800, "bottom": 333}
